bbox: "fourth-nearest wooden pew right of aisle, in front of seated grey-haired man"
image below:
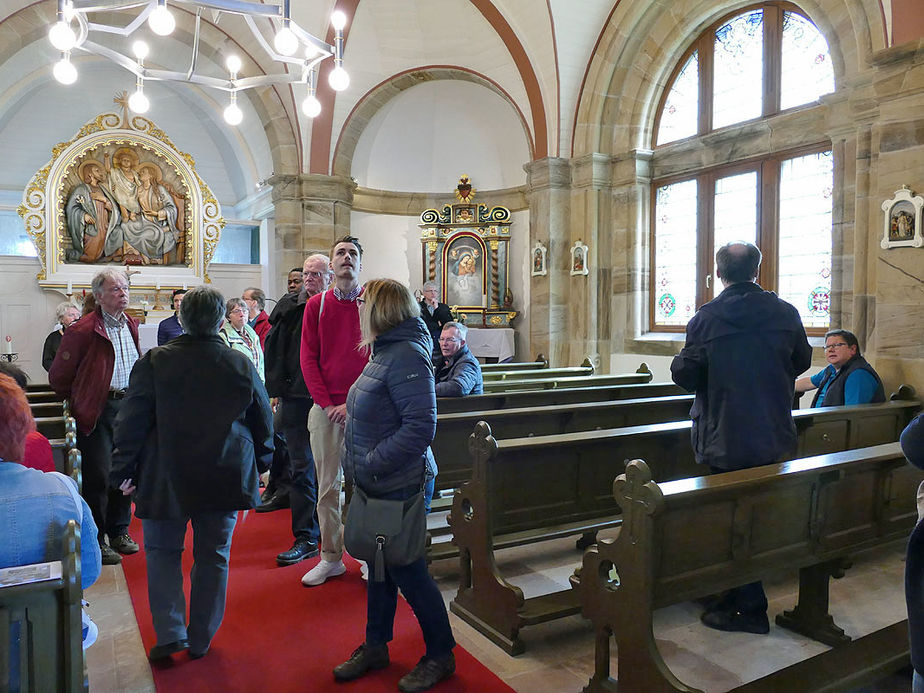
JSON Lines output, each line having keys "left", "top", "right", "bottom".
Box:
{"left": 436, "top": 370, "right": 686, "bottom": 414}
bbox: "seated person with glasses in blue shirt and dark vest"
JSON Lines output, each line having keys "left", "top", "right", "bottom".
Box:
{"left": 796, "top": 330, "right": 885, "bottom": 408}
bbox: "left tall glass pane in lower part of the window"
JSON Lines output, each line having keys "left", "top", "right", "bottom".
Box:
{"left": 654, "top": 180, "right": 696, "bottom": 326}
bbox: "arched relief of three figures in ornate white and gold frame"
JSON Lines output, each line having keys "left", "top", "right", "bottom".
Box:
{"left": 19, "top": 93, "right": 224, "bottom": 292}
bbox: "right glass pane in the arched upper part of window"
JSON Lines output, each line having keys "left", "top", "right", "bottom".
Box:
{"left": 780, "top": 12, "right": 834, "bottom": 109}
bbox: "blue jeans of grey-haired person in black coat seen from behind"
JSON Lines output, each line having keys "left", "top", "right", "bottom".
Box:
{"left": 142, "top": 510, "right": 237, "bottom": 653}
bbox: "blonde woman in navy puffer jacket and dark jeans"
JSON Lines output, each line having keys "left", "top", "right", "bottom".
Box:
{"left": 334, "top": 279, "right": 455, "bottom": 692}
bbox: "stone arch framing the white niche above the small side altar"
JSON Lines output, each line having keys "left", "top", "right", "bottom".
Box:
{"left": 333, "top": 65, "right": 535, "bottom": 177}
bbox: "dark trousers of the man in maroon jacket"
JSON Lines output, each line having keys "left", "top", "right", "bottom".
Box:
{"left": 77, "top": 397, "right": 132, "bottom": 544}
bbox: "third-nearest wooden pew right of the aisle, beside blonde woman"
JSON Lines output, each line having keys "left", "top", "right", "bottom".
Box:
{"left": 430, "top": 395, "right": 693, "bottom": 491}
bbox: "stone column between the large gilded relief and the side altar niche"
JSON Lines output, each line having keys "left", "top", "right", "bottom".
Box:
{"left": 268, "top": 173, "right": 356, "bottom": 293}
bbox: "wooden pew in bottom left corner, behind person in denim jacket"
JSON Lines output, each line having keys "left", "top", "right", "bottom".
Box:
{"left": 0, "top": 520, "right": 85, "bottom": 693}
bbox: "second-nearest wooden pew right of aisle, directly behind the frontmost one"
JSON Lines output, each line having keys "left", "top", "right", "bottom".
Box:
{"left": 446, "top": 400, "right": 921, "bottom": 654}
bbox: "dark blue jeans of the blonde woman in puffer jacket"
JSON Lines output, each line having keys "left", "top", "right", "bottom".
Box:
{"left": 366, "top": 486, "right": 456, "bottom": 659}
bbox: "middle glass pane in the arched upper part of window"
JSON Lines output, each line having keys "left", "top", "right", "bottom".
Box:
{"left": 712, "top": 10, "right": 764, "bottom": 128}
